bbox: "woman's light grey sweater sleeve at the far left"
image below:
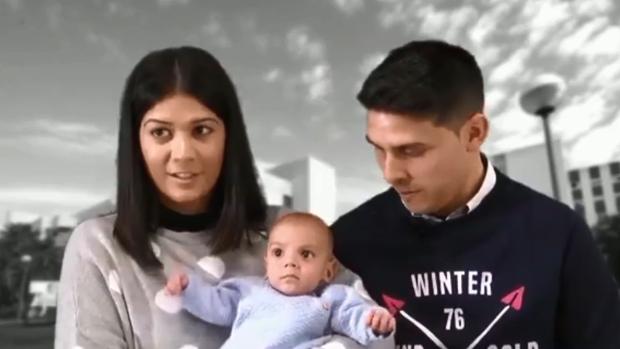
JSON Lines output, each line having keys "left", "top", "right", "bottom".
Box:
{"left": 54, "top": 222, "right": 132, "bottom": 349}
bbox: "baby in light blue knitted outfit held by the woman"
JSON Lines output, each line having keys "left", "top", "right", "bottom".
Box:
{"left": 166, "top": 213, "right": 395, "bottom": 349}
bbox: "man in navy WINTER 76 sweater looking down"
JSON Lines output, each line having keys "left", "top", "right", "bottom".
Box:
{"left": 333, "top": 41, "right": 620, "bottom": 349}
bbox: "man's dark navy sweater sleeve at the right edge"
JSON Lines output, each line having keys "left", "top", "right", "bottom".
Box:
{"left": 556, "top": 213, "right": 620, "bottom": 349}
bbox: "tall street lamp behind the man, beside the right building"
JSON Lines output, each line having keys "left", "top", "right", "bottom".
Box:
{"left": 520, "top": 75, "right": 565, "bottom": 200}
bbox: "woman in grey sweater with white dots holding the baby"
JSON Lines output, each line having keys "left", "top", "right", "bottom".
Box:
{"left": 55, "top": 47, "right": 390, "bottom": 349}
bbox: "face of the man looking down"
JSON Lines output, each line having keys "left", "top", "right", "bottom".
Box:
{"left": 366, "top": 110, "right": 472, "bottom": 216}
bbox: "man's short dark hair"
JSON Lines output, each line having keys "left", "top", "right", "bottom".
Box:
{"left": 357, "top": 40, "right": 484, "bottom": 125}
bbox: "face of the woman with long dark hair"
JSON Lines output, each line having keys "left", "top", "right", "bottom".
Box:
{"left": 140, "top": 94, "right": 226, "bottom": 214}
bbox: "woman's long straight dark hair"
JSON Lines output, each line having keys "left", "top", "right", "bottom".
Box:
{"left": 114, "top": 47, "right": 267, "bottom": 268}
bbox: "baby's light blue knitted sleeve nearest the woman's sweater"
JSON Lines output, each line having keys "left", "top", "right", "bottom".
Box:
{"left": 183, "top": 273, "right": 249, "bottom": 326}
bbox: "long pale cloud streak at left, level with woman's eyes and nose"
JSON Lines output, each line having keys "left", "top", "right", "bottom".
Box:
{"left": 0, "top": 119, "right": 116, "bottom": 157}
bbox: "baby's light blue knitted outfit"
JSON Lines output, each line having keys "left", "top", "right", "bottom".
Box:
{"left": 183, "top": 274, "right": 380, "bottom": 349}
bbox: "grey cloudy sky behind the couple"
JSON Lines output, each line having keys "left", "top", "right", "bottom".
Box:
{"left": 0, "top": 0, "right": 620, "bottom": 221}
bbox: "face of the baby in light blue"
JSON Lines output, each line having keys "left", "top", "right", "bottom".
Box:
{"left": 265, "top": 222, "right": 334, "bottom": 296}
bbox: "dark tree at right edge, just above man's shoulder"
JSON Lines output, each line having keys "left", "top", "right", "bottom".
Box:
{"left": 593, "top": 215, "right": 620, "bottom": 282}
